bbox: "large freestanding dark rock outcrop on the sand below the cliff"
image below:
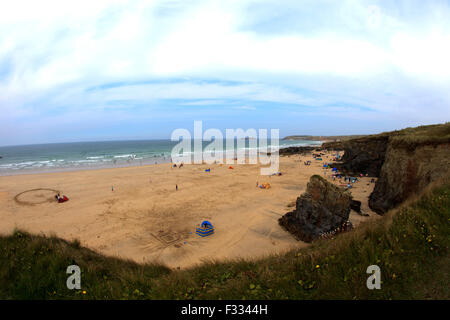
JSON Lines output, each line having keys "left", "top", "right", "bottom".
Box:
{"left": 278, "top": 175, "right": 352, "bottom": 242}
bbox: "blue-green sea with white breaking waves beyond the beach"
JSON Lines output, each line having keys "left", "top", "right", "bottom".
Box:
{"left": 0, "top": 139, "right": 322, "bottom": 176}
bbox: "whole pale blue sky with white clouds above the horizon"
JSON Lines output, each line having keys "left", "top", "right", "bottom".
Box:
{"left": 0, "top": 0, "right": 450, "bottom": 146}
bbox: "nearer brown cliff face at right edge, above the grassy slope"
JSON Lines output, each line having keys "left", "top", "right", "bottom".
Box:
{"left": 369, "top": 142, "right": 450, "bottom": 214}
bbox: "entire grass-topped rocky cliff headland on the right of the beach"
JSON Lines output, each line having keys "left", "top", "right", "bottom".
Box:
{"left": 323, "top": 123, "right": 450, "bottom": 214}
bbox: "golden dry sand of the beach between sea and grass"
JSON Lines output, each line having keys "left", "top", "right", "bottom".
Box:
{"left": 0, "top": 153, "right": 377, "bottom": 268}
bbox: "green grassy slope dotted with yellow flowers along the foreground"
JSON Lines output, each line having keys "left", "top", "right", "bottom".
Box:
{"left": 0, "top": 183, "right": 450, "bottom": 299}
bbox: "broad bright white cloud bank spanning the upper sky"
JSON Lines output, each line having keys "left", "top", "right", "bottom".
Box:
{"left": 0, "top": 0, "right": 450, "bottom": 92}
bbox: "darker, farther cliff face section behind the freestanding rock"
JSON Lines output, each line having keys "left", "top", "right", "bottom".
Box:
{"left": 323, "top": 135, "right": 389, "bottom": 177}
